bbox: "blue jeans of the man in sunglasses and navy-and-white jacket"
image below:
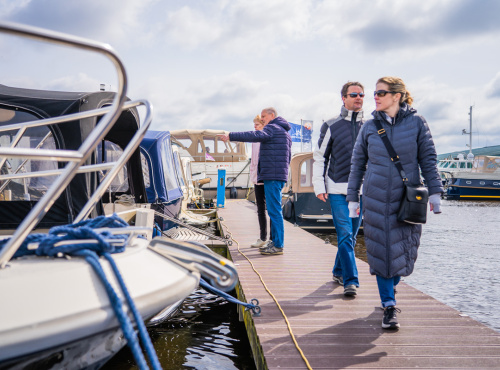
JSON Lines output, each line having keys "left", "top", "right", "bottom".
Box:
{"left": 328, "top": 194, "right": 362, "bottom": 287}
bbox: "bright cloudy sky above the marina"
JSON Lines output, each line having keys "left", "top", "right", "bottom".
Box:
{"left": 0, "top": 0, "right": 500, "bottom": 153}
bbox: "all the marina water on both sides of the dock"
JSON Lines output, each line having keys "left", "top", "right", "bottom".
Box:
{"left": 104, "top": 200, "right": 500, "bottom": 370}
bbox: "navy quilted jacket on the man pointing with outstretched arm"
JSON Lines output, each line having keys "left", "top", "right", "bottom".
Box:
{"left": 229, "top": 117, "right": 292, "bottom": 182}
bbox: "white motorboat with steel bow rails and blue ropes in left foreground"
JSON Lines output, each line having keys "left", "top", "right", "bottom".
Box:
{"left": 0, "top": 22, "right": 236, "bottom": 369}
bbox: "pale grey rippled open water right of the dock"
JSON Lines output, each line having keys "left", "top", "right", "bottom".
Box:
{"left": 315, "top": 200, "right": 500, "bottom": 331}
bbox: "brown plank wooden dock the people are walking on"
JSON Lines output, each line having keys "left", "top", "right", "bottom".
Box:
{"left": 219, "top": 200, "right": 500, "bottom": 370}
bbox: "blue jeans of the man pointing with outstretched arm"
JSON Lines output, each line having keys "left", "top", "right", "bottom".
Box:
{"left": 264, "top": 180, "right": 285, "bottom": 248}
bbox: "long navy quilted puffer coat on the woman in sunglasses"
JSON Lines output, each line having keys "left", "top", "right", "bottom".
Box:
{"left": 347, "top": 104, "right": 443, "bottom": 278}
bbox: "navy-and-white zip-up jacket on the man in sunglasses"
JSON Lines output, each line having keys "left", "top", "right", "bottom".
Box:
{"left": 313, "top": 106, "right": 363, "bottom": 195}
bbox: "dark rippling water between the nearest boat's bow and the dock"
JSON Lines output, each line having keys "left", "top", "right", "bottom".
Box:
{"left": 103, "top": 288, "right": 255, "bottom": 370}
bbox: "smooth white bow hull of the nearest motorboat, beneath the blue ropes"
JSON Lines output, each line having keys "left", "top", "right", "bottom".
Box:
{"left": 0, "top": 239, "right": 200, "bottom": 364}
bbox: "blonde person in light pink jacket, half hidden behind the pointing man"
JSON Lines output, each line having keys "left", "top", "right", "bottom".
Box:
{"left": 250, "top": 114, "right": 272, "bottom": 249}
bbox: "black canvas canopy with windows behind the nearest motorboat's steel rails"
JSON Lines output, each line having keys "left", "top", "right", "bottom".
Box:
{"left": 0, "top": 84, "right": 146, "bottom": 229}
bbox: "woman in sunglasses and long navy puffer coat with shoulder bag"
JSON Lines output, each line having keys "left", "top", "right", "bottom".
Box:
{"left": 347, "top": 77, "right": 443, "bottom": 329}
